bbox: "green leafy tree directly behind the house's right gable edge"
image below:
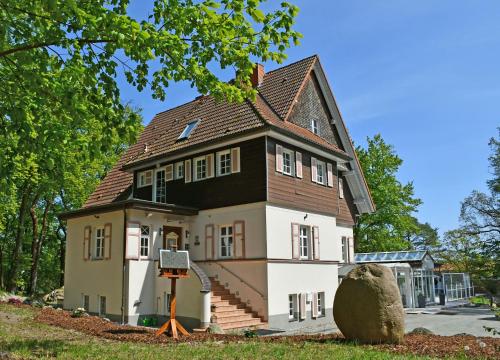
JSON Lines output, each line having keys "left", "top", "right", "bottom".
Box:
{"left": 355, "top": 135, "right": 423, "bottom": 252}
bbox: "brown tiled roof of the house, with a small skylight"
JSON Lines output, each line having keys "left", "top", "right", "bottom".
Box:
{"left": 84, "top": 56, "right": 348, "bottom": 207}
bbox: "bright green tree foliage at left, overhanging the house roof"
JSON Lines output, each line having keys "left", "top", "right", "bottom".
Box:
{"left": 0, "top": 0, "right": 301, "bottom": 293}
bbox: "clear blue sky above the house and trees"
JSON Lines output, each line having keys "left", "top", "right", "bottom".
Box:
{"left": 122, "top": 0, "right": 500, "bottom": 232}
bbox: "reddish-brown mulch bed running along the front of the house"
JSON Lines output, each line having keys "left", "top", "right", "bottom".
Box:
{"left": 35, "top": 308, "right": 500, "bottom": 359}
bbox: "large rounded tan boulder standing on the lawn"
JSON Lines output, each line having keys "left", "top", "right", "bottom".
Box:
{"left": 333, "top": 264, "right": 404, "bottom": 344}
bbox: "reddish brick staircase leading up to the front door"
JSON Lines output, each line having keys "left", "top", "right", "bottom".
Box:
{"left": 210, "top": 278, "right": 267, "bottom": 330}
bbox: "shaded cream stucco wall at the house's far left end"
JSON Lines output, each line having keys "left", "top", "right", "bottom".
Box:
{"left": 64, "top": 211, "right": 123, "bottom": 316}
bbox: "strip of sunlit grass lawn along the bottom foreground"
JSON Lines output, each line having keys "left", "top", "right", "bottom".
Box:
{"left": 0, "top": 304, "right": 442, "bottom": 360}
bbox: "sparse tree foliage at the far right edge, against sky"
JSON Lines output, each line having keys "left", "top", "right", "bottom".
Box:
{"left": 442, "top": 128, "right": 500, "bottom": 282}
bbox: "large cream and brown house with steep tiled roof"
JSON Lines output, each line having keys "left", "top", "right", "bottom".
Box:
{"left": 61, "top": 56, "right": 374, "bottom": 329}
